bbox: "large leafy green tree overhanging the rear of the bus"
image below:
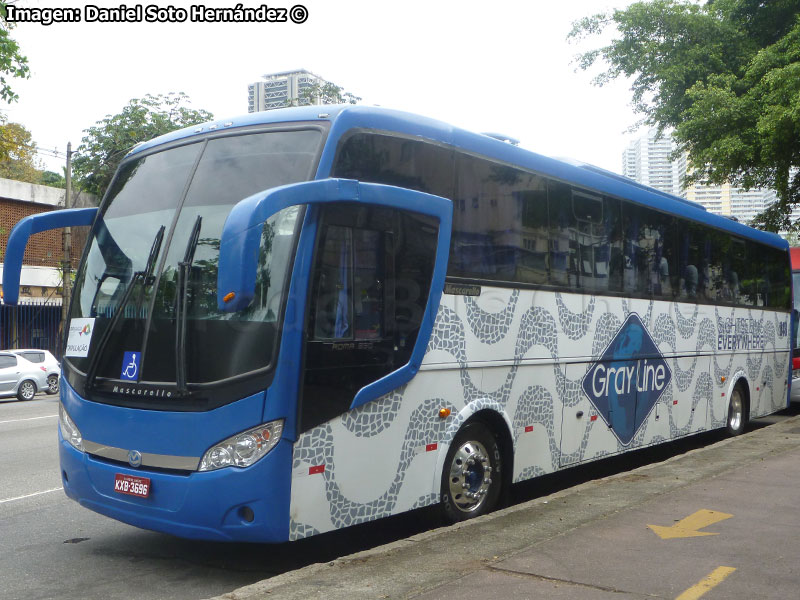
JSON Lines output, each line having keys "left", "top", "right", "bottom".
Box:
{"left": 569, "top": 0, "right": 800, "bottom": 231}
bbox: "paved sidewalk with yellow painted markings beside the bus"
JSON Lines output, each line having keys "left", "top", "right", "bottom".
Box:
{"left": 209, "top": 416, "right": 800, "bottom": 600}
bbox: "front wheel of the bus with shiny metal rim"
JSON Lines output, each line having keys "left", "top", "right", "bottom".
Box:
{"left": 441, "top": 421, "right": 503, "bottom": 523}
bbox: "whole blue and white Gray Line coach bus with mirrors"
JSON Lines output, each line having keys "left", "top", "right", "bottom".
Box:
{"left": 3, "top": 106, "right": 792, "bottom": 542}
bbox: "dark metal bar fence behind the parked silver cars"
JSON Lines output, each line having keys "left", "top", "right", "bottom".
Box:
{"left": 0, "top": 299, "right": 61, "bottom": 357}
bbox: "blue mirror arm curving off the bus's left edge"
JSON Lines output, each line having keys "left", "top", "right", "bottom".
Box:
{"left": 3, "top": 208, "right": 97, "bottom": 306}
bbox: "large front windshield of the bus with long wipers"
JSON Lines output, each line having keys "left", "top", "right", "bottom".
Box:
{"left": 65, "top": 128, "right": 323, "bottom": 395}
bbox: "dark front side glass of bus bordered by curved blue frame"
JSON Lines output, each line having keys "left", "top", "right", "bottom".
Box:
{"left": 300, "top": 203, "right": 438, "bottom": 431}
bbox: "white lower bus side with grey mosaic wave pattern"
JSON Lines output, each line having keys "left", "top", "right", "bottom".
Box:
{"left": 290, "top": 286, "right": 789, "bottom": 539}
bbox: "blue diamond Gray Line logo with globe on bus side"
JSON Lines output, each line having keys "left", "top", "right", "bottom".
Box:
{"left": 582, "top": 313, "right": 672, "bottom": 446}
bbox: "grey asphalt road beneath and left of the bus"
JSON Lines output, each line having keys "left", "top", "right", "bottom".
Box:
{"left": 0, "top": 395, "right": 798, "bottom": 600}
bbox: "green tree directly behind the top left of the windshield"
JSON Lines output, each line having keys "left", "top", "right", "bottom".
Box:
{"left": 72, "top": 93, "right": 214, "bottom": 198}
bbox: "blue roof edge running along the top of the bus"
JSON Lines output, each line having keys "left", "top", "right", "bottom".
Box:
{"left": 128, "top": 104, "right": 788, "bottom": 251}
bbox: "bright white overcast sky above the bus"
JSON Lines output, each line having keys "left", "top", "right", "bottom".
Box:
{"left": 0, "top": 0, "right": 638, "bottom": 173}
